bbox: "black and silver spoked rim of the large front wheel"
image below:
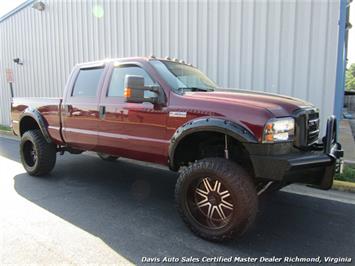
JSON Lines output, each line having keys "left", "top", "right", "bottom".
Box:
{"left": 187, "top": 177, "right": 235, "bottom": 230}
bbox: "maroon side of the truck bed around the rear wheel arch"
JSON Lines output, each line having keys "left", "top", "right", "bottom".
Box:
{"left": 11, "top": 97, "right": 63, "bottom": 144}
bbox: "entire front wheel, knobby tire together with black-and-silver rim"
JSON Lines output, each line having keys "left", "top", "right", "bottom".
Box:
{"left": 175, "top": 158, "right": 258, "bottom": 241}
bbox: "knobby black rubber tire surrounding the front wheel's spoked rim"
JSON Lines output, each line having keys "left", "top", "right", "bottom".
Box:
{"left": 175, "top": 158, "right": 258, "bottom": 241}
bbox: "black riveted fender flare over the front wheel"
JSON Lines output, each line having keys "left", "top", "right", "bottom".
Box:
{"left": 168, "top": 118, "right": 258, "bottom": 170}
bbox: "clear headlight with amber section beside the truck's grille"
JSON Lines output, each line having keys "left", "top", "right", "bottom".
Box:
{"left": 263, "top": 117, "right": 295, "bottom": 143}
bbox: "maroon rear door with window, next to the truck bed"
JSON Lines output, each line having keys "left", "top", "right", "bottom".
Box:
{"left": 62, "top": 62, "right": 106, "bottom": 150}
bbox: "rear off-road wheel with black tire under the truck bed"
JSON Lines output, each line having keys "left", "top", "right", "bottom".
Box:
{"left": 20, "top": 129, "right": 56, "bottom": 176}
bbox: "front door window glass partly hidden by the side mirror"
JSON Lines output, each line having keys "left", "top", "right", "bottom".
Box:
{"left": 107, "top": 66, "right": 155, "bottom": 98}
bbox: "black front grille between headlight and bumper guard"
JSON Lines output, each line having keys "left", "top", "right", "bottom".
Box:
{"left": 294, "top": 109, "right": 319, "bottom": 148}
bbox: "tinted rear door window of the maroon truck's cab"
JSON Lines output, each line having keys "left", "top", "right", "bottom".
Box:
{"left": 72, "top": 68, "right": 103, "bottom": 97}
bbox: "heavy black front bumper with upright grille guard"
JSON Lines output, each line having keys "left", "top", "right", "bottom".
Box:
{"left": 250, "top": 116, "right": 343, "bottom": 189}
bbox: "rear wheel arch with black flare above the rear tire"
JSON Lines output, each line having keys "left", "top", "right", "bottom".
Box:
{"left": 19, "top": 108, "right": 52, "bottom": 143}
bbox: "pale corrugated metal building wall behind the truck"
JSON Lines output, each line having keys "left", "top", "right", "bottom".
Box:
{"left": 0, "top": 0, "right": 339, "bottom": 133}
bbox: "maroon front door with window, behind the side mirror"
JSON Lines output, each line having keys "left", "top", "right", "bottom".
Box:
{"left": 99, "top": 64, "right": 169, "bottom": 163}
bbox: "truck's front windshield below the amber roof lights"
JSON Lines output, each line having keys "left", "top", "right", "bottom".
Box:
{"left": 150, "top": 60, "right": 218, "bottom": 93}
